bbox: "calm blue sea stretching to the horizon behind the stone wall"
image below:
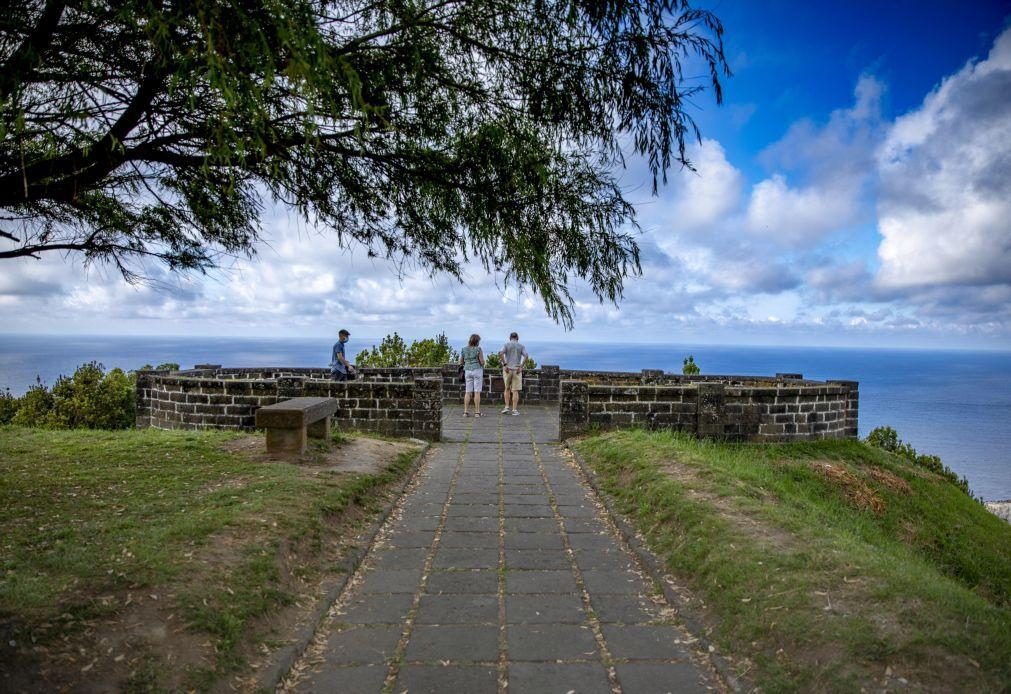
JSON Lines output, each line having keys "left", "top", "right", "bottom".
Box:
{"left": 0, "top": 335, "right": 1011, "bottom": 500}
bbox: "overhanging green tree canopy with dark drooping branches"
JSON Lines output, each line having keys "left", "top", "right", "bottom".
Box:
{"left": 0, "top": 0, "right": 729, "bottom": 323}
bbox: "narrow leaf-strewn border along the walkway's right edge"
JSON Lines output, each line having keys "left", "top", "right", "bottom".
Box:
{"left": 563, "top": 443, "right": 754, "bottom": 693}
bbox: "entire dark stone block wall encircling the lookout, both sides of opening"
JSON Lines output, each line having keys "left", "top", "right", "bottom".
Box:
{"left": 136, "top": 364, "right": 859, "bottom": 442}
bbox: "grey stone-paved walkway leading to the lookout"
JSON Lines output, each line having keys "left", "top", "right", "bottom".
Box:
{"left": 291, "top": 404, "right": 722, "bottom": 694}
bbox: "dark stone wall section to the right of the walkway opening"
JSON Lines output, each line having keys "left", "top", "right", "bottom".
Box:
{"left": 559, "top": 369, "right": 859, "bottom": 442}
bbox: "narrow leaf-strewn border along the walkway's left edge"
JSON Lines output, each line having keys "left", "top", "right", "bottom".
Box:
{"left": 257, "top": 442, "right": 431, "bottom": 692}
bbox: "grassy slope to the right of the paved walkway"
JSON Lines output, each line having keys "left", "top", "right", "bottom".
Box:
{"left": 576, "top": 431, "right": 1011, "bottom": 691}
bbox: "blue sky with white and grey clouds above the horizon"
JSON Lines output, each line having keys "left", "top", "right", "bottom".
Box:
{"left": 0, "top": 0, "right": 1011, "bottom": 349}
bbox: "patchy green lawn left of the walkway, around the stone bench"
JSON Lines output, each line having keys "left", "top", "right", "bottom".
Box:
{"left": 0, "top": 427, "right": 412, "bottom": 688}
